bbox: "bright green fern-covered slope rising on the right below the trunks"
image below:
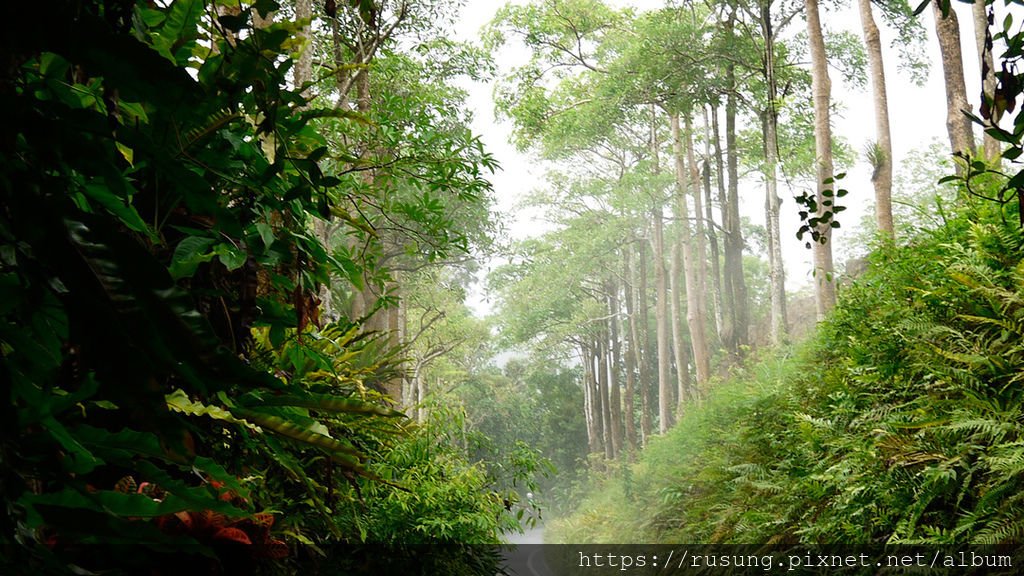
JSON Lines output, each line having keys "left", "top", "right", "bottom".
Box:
{"left": 556, "top": 192, "right": 1024, "bottom": 543}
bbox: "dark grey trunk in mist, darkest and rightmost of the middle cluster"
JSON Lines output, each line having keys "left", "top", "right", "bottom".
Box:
{"left": 716, "top": 58, "right": 750, "bottom": 349}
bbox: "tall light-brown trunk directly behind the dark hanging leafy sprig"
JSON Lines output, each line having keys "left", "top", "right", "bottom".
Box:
{"left": 804, "top": 0, "right": 836, "bottom": 321}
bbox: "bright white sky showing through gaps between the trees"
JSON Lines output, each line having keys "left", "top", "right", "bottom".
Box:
{"left": 457, "top": 0, "right": 1019, "bottom": 314}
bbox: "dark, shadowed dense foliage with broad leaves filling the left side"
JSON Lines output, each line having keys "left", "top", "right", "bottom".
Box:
{"left": 0, "top": 0, "right": 515, "bottom": 574}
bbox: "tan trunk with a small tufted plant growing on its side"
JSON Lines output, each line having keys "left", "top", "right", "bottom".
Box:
{"left": 857, "top": 0, "right": 896, "bottom": 240}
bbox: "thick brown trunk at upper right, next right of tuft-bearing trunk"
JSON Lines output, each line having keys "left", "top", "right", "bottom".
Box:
{"left": 932, "top": 0, "right": 974, "bottom": 163}
